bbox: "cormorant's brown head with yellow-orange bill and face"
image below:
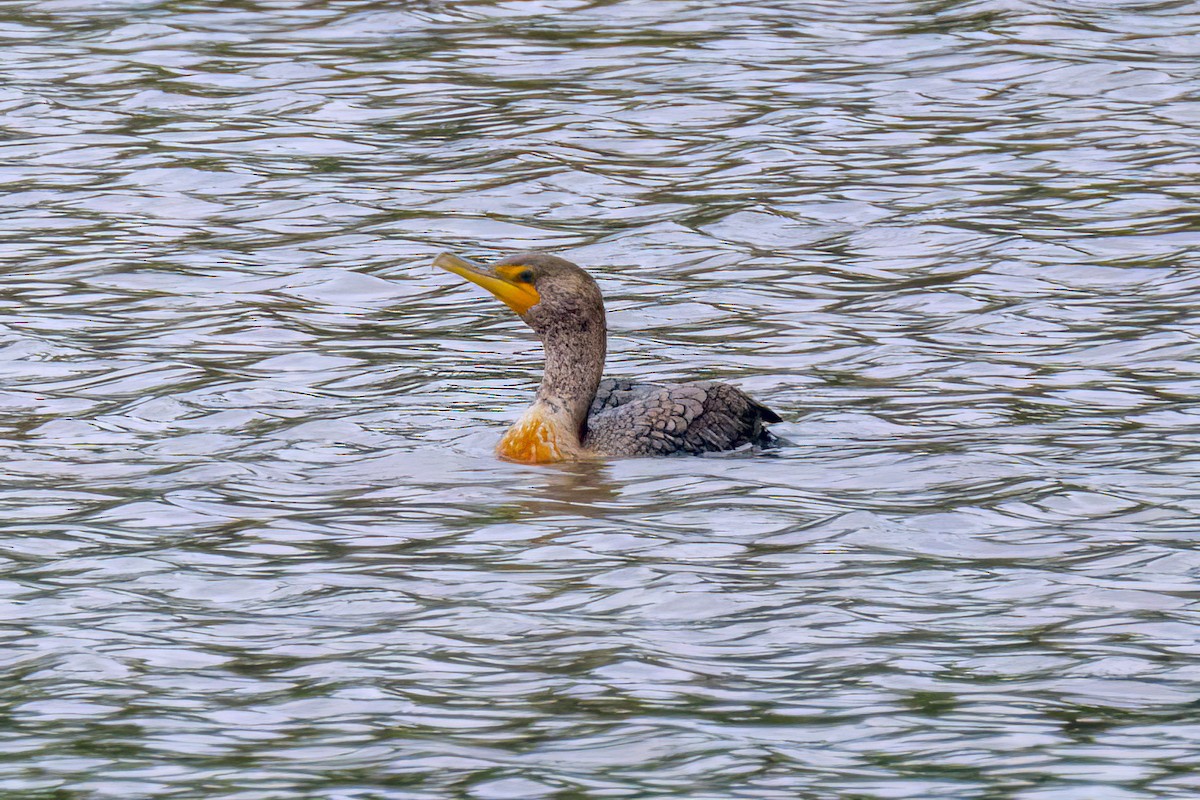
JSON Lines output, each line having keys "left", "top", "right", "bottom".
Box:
{"left": 433, "top": 251, "right": 604, "bottom": 337}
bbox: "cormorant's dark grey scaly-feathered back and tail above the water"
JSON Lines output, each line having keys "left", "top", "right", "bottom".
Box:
{"left": 583, "top": 379, "right": 780, "bottom": 456}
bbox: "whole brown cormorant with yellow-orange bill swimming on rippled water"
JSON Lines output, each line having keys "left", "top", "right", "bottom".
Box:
{"left": 433, "top": 251, "right": 780, "bottom": 464}
